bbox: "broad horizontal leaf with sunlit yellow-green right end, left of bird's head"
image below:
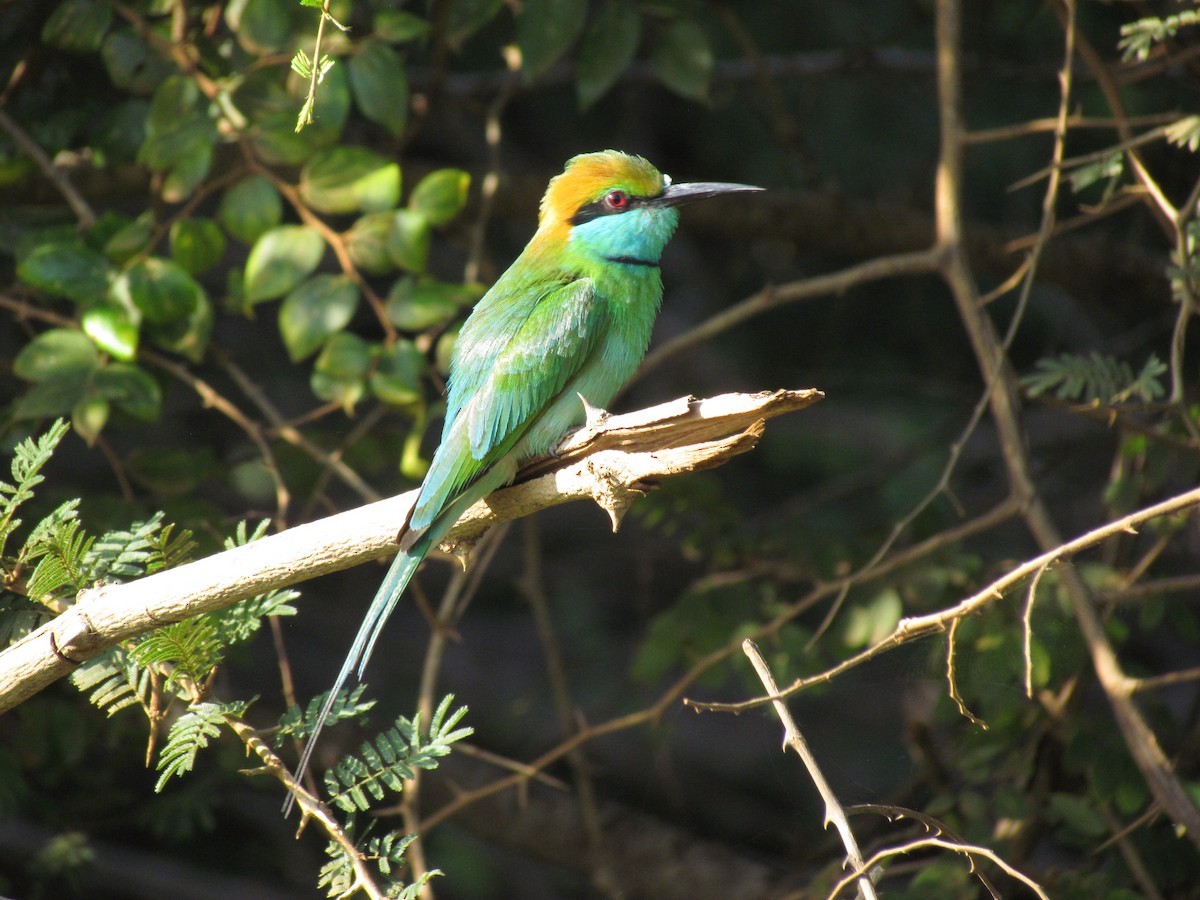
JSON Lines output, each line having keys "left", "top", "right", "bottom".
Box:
{"left": 300, "top": 146, "right": 400, "bottom": 214}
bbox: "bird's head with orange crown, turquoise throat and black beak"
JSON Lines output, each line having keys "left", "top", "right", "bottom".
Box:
{"left": 538, "top": 150, "right": 762, "bottom": 265}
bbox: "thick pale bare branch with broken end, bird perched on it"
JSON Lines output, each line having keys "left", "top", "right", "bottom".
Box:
{"left": 0, "top": 390, "right": 823, "bottom": 713}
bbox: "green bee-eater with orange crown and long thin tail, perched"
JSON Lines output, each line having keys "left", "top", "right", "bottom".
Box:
{"left": 284, "top": 150, "right": 763, "bottom": 812}
